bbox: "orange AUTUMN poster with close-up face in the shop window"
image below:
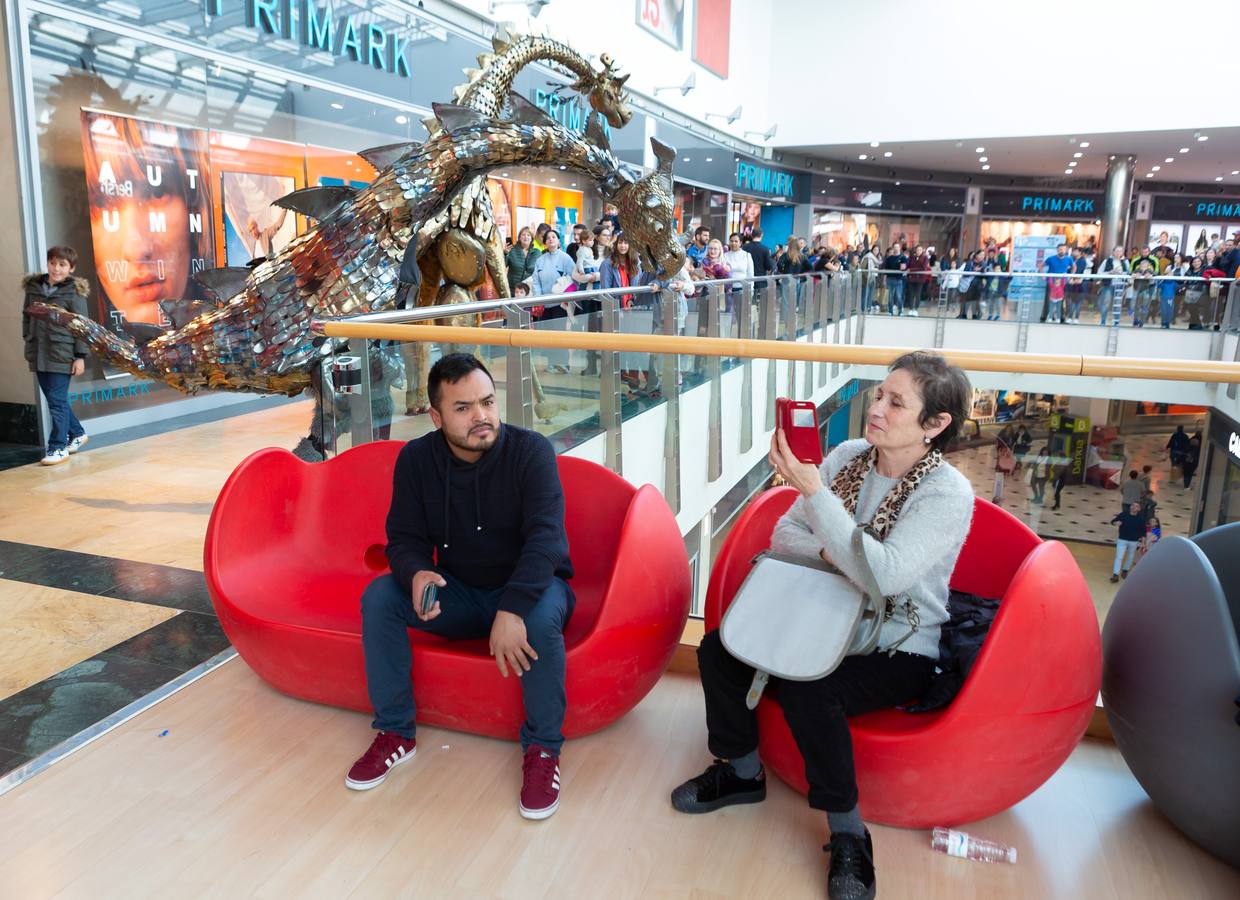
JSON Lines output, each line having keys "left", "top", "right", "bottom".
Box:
{"left": 82, "top": 110, "right": 215, "bottom": 329}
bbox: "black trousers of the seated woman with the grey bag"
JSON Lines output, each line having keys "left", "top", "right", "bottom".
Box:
{"left": 698, "top": 631, "right": 935, "bottom": 812}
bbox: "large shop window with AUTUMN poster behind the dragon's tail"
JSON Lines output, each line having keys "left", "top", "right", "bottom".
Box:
{"left": 29, "top": 14, "right": 414, "bottom": 419}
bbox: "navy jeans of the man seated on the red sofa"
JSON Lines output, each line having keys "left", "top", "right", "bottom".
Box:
{"left": 362, "top": 573, "right": 577, "bottom": 754}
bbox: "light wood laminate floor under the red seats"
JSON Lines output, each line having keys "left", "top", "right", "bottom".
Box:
{"left": 0, "top": 660, "right": 1240, "bottom": 900}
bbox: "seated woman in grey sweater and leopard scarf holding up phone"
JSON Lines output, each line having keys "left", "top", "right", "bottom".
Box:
{"left": 672, "top": 352, "right": 973, "bottom": 900}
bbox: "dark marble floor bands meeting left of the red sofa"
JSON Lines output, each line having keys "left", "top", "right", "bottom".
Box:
{"left": 0, "top": 540, "right": 228, "bottom": 775}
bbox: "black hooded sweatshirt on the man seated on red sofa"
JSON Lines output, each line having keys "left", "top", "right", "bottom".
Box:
{"left": 387, "top": 424, "right": 573, "bottom": 617}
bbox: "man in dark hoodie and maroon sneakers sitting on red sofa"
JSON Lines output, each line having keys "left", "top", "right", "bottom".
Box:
{"left": 345, "top": 353, "right": 575, "bottom": 819}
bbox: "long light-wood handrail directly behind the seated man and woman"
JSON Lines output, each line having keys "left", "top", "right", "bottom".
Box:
{"left": 321, "top": 321, "right": 1240, "bottom": 384}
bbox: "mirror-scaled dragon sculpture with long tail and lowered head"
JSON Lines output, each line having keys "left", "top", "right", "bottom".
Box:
{"left": 31, "top": 97, "right": 683, "bottom": 452}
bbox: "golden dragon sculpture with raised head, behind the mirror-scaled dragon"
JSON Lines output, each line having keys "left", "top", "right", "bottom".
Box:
{"left": 407, "top": 26, "right": 632, "bottom": 418}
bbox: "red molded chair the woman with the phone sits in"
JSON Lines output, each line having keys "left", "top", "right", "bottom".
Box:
{"left": 706, "top": 487, "right": 1102, "bottom": 828}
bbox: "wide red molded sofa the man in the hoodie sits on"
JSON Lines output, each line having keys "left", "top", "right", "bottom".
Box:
{"left": 205, "top": 441, "right": 691, "bottom": 739}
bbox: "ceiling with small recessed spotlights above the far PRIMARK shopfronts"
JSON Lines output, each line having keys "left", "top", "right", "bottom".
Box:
{"left": 780, "top": 128, "right": 1240, "bottom": 192}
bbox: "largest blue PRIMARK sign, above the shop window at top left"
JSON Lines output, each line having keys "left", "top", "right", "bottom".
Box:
{"left": 206, "top": 0, "right": 409, "bottom": 78}
